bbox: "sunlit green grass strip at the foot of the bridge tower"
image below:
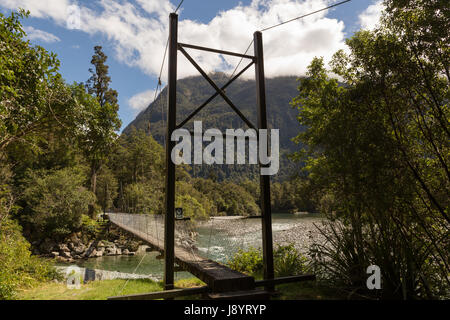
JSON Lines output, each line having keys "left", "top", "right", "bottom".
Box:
{"left": 18, "top": 278, "right": 204, "bottom": 300}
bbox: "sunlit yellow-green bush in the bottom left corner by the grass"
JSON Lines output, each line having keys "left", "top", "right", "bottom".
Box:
{"left": 0, "top": 219, "right": 58, "bottom": 300}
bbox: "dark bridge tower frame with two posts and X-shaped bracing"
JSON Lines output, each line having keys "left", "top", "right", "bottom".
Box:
{"left": 164, "top": 13, "right": 274, "bottom": 291}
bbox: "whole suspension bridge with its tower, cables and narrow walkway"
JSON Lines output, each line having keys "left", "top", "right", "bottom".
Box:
{"left": 110, "top": 0, "right": 350, "bottom": 299}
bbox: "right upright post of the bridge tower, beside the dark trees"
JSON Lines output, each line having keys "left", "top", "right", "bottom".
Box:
{"left": 253, "top": 31, "right": 275, "bottom": 291}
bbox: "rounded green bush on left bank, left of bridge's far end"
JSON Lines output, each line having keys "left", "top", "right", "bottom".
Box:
{"left": 22, "top": 168, "right": 95, "bottom": 238}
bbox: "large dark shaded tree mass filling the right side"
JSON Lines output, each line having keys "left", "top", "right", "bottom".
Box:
{"left": 293, "top": 0, "right": 450, "bottom": 299}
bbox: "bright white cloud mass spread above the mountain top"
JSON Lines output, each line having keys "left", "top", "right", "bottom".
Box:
{"left": 0, "top": 0, "right": 345, "bottom": 81}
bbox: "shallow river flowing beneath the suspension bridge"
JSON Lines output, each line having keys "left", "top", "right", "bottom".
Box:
{"left": 72, "top": 214, "right": 321, "bottom": 279}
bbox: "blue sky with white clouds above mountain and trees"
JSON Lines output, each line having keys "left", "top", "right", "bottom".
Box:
{"left": 0, "top": 0, "right": 380, "bottom": 129}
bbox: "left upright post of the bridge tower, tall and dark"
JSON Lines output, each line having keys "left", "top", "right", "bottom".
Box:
{"left": 164, "top": 13, "right": 178, "bottom": 290}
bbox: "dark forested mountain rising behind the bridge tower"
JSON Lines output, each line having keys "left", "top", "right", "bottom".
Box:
{"left": 123, "top": 73, "right": 301, "bottom": 180}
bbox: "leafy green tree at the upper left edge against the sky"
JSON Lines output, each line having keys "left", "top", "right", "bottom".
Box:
{"left": 0, "top": 10, "right": 77, "bottom": 151}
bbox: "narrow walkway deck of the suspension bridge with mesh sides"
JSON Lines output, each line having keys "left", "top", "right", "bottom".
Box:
{"left": 107, "top": 213, "right": 314, "bottom": 300}
